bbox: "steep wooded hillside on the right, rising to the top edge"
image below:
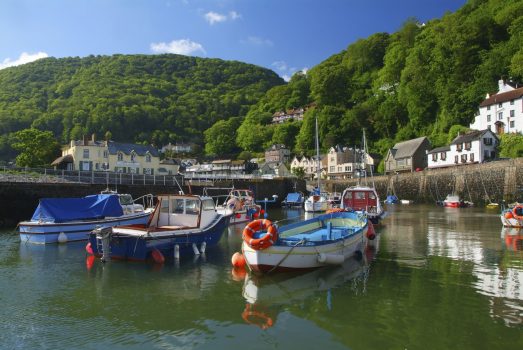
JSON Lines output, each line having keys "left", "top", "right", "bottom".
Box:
{"left": 236, "top": 0, "right": 523, "bottom": 163}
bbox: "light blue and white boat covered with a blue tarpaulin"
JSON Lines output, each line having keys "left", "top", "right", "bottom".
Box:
{"left": 18, "top": 193, "right": 153, "bottom": 244}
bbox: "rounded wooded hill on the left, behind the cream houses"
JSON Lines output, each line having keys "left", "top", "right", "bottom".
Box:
{"left": 0, "top": 55, "right": 284, "bottom": 160}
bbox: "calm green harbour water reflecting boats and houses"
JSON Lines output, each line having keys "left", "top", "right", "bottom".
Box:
{"left": 0, "top": 205, "right": 523, "bottom": 350}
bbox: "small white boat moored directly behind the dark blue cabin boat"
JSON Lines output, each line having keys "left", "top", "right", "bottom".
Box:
{"left": 203, "top": 187, "right": 262, "bottom": 225}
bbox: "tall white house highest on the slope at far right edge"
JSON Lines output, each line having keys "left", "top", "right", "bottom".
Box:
{"left": 470, "top": 80, "right": 523, "bottom": 135}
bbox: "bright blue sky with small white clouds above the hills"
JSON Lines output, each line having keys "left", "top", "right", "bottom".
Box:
{"left": 0, "top": 0, "right": 466, "bottom": 80}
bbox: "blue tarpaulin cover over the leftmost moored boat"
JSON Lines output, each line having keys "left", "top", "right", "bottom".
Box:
{"left": 31, "top": 194, "right": 123, "bottom": 223}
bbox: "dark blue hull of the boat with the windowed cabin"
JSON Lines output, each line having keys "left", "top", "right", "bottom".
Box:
{"left": 89, "top": 216, "right": 229, "bottom": 261}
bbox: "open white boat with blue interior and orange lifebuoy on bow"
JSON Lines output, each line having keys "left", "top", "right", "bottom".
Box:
{"left": 242, "top": 211, "right": 375, "bottom": 273}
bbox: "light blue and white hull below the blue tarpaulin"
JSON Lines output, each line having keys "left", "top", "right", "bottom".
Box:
{"left": 18, "top": 212, "right": 151, "bottom": 244}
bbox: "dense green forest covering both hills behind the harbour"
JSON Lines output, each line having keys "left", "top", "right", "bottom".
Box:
{"left": 0, "top": 0, "right": 523, "bottom": 168}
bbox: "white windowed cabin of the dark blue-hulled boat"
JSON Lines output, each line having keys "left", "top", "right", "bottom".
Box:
{"left": 149, "top": 195, "right": 218, "bottom": 229}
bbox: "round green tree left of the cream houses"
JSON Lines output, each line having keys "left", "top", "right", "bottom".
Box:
{"left": 12, "top": 129, "right": 60, "bottom": 168}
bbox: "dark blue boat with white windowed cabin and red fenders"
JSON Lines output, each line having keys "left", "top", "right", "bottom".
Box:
{"left": 86, "top": 194, "right": 230, "bottom": 262}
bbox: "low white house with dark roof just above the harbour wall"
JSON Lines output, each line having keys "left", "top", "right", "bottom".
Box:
{"left": 427, "top": 129, "right": 499, "bottom": 169}
